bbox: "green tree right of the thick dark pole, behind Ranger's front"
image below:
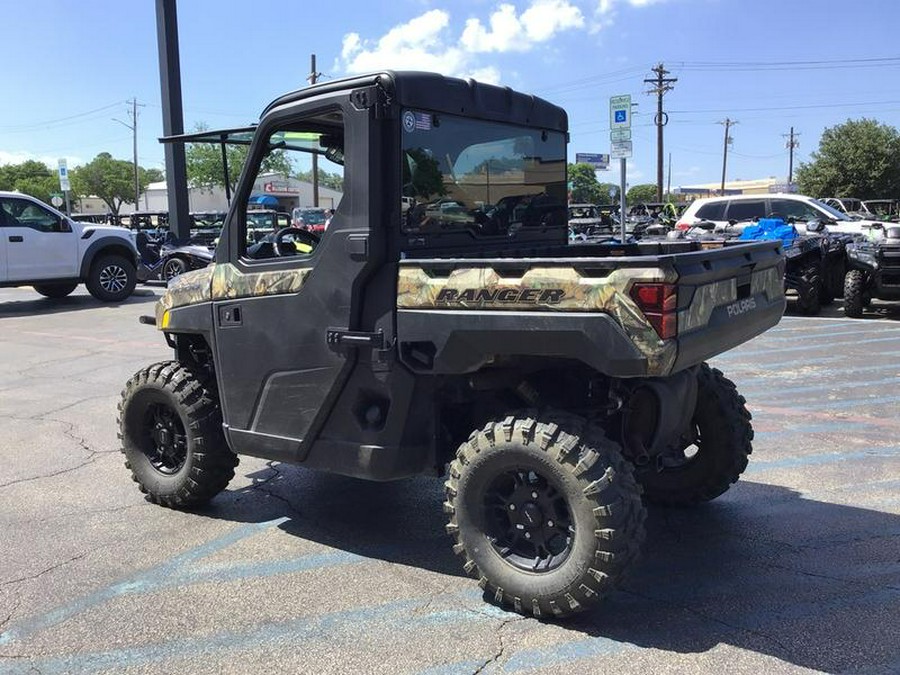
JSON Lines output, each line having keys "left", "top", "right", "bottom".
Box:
{"left": 185, "top": 122, "right": 293, "bottom": 192}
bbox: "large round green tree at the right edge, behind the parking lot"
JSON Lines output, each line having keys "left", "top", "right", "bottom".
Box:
{"left": 796, "top": 118, "right": 900, "bottom": 199}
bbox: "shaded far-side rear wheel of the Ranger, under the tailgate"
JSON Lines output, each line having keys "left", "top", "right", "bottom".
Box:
{"left": 638, "top": 363, "right": 753, "bottom": 506}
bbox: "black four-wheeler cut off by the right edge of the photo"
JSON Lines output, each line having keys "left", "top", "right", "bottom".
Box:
{"left": 844, "top": 224, "right": 900, "bottom": 318}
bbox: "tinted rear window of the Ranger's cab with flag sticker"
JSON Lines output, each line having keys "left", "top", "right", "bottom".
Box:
{"left": 401, "top": 110, "right": 567, "bottom": 236}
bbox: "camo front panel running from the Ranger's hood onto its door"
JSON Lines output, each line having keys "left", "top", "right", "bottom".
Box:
{"left": 156, "top": 263, "right": 310, "bottom": 326}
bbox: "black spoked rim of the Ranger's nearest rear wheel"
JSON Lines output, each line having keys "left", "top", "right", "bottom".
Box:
{"left": 484, "top": 469, "right": 575, "bottom": 573}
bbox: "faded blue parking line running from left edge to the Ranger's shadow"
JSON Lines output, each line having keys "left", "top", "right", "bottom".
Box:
{"left": 0, "top": 518, "right": 287, "bottom": 646}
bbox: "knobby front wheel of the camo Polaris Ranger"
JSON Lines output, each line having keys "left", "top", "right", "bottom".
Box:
{"left": 118, "top": 361, "right": 238, "bottom": 508}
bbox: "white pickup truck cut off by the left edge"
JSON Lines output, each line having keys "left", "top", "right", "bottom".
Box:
{"left": 0, "top": 192, "right": 139, "bottom": 302}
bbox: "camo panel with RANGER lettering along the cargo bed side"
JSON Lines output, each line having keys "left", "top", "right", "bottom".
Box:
{"left": 397, "top": 265, "right": 677, "bottom": 375}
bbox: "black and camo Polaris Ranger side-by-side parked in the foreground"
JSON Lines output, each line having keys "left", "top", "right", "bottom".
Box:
{"left": 119, "top": 72, "right": 785, "bottom": 617}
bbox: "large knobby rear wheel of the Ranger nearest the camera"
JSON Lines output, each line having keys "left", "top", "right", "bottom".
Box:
{"left": 444, "top": 415, "right": 646, "bottom": 617}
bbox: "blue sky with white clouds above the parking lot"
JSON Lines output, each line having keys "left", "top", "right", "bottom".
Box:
{"left": 0, "top": 0, "right": 900, "bottom": 187}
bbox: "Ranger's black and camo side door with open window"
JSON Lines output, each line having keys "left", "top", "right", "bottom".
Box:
{"left": 212, "top": 109, "right": 368, "bottom": 459}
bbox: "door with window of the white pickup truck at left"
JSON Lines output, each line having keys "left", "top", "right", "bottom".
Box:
{"left": 0, "top": 197, "right": 79, "bottom": 281}
